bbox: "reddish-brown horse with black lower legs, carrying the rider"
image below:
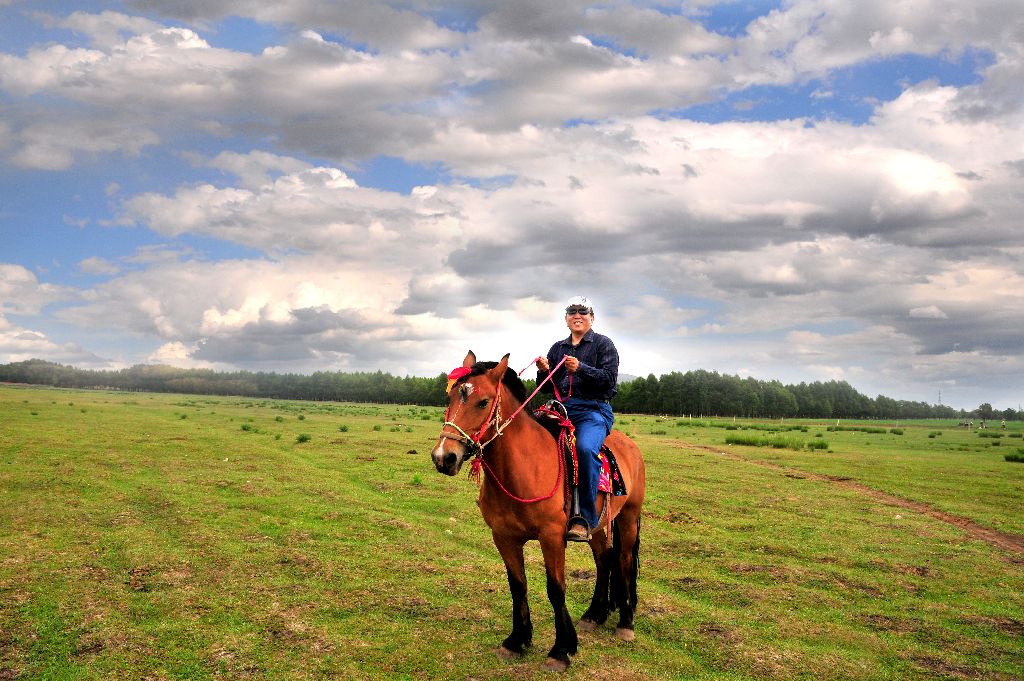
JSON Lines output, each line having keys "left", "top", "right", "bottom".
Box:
{"left": 432, "top": 351, "right": 645, "bottom": 671}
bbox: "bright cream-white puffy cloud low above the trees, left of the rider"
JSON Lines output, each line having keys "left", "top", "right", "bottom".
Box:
{"left": 50, "top": 257, "right": 432, "bottom": 369}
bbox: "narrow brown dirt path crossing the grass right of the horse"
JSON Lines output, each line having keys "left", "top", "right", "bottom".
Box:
{"left": 680, "top": 442, "right": 1024, "bottom": 563}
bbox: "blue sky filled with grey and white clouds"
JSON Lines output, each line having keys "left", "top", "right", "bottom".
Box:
{"left": 0, "top": 0, "right": 1024, "bottom": 410}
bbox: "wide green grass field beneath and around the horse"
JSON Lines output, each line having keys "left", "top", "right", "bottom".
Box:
{"left": 0, "top": 386, "right": 1024, "bottom": 679}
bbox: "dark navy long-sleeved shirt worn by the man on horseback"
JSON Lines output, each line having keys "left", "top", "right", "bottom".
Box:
{"left": 537, "top": 329, "right": 618, "bottom": 400}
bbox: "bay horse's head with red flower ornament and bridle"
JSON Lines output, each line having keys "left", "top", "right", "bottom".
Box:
{"left": 431, "top": 350, "right": 515, "bottom": 475}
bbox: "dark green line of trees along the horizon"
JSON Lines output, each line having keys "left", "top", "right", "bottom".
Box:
{"left": 0, "top": 359, "right": 1024, "bottom": 420}
